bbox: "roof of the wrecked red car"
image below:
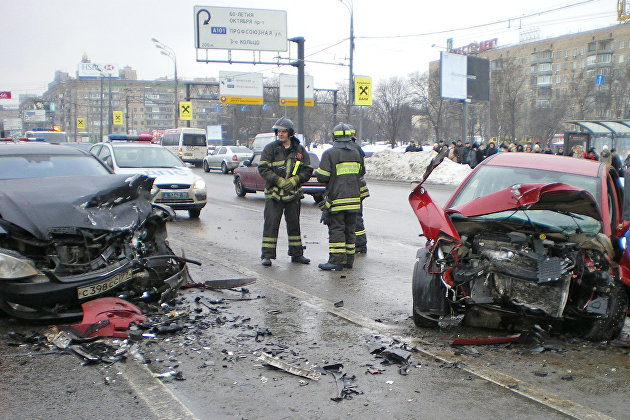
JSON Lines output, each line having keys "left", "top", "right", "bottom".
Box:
{"left": 482, "top": 152, "right": 602, "bottom": 177}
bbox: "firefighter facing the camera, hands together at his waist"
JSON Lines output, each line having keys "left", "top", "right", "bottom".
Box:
{"left": 258, "top": 117, "right": 313, "bottom": 267}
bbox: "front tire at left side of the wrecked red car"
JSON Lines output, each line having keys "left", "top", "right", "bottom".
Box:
{"left": 411, "top": 249, "right": 446, "bottom": 328}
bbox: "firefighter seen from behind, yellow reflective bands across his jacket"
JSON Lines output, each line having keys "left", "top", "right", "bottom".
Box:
{"left": 315, "top": 123, "right": 365, "bottom": 271}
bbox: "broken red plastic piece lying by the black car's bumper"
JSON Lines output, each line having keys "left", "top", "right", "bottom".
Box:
{"left": 72, "top": 297, "right": 147, "bottom": 338}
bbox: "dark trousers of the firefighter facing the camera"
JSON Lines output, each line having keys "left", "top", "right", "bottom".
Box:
{"left": 261, "top": 199, "right": 304, "bottom": 259}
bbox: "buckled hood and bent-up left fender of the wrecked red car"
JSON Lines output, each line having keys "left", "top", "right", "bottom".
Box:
{"left": 409, "top": 183, "right": 601, "bottom": 240}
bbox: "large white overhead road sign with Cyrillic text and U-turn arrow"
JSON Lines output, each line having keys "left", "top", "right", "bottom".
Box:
{"left": 194, "top": 6, "right": 288, "bottom": 51}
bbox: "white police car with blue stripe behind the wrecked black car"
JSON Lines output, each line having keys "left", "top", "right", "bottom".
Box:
{"left": 90, "top": 135, "right": 207, "bottom": 218}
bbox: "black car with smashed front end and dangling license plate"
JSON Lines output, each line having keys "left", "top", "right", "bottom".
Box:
{"left": 0, "top": 142, "right": 188, "bottom": 320}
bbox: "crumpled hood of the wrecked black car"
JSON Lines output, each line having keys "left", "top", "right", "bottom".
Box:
{"left": 0, "top": 175, "right": 153, "bottom": 240}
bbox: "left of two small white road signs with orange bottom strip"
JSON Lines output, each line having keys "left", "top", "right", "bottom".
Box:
{"left": 219, "top": 71, "right": 263, "bottom": 105}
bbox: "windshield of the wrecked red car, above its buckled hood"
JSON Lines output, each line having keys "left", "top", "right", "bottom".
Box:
{"left": 450, "top": 165, "right": 601, "bottom": 207}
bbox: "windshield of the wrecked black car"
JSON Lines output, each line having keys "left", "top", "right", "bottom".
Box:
{"left": 0, "top": 155, "right": 110, "bottom": 179}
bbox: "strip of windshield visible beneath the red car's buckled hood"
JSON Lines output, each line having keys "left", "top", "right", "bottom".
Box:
{"left": 469, "top": 210, "right": 601, "bottom": 235}
